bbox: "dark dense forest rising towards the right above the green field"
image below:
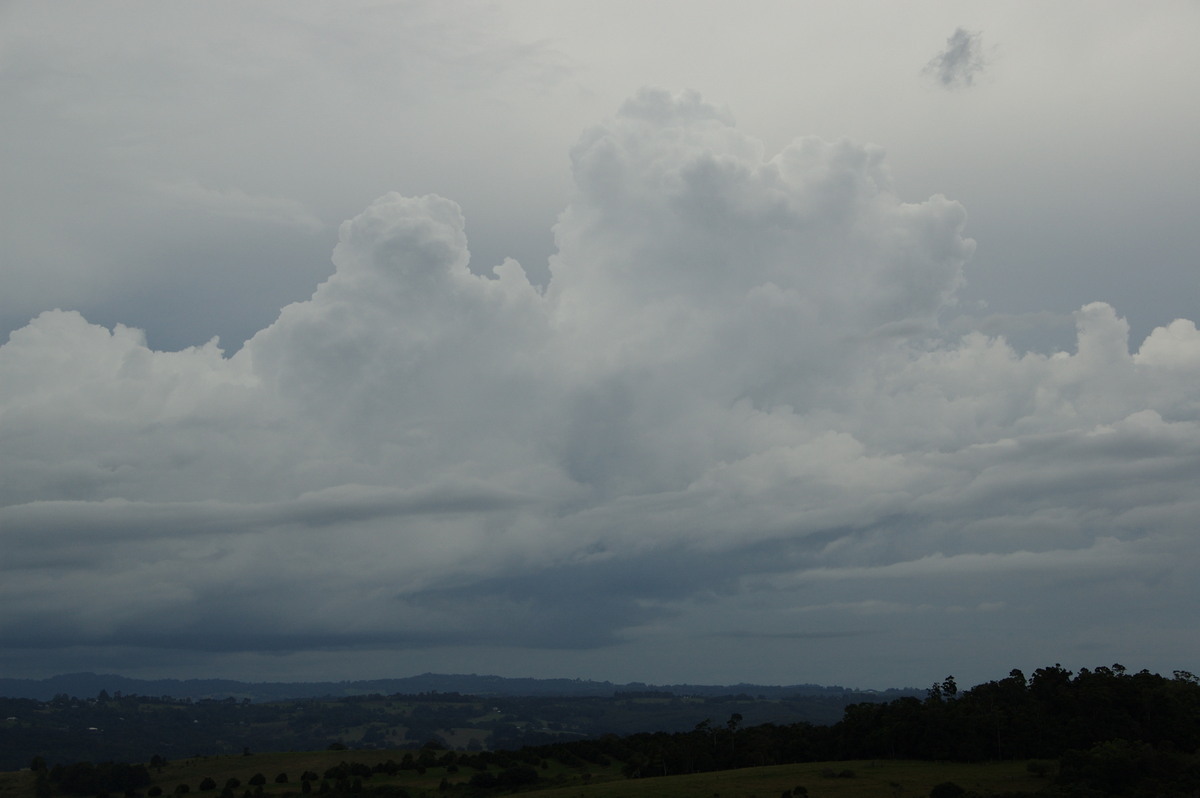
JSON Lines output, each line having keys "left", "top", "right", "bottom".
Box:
{"left": 523, "top": 665, "right": 1200, "bottom": 782}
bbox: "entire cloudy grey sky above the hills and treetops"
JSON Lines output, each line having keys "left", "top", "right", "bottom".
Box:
{"left": 0, "top": 0, "right": 1200, "bottom": 688}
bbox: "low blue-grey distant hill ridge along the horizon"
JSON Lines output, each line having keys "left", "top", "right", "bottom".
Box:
{"left": 0, "top": 673, "right": 913, "bottom": 701}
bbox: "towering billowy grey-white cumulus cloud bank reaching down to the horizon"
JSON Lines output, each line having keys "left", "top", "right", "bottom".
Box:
{"left": 0, "top": 90, "right": 1200, "bottom": 680}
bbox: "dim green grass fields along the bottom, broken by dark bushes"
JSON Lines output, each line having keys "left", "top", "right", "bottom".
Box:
{"left": 0, "top": 751, "right": 1048, "bottom": 798}
